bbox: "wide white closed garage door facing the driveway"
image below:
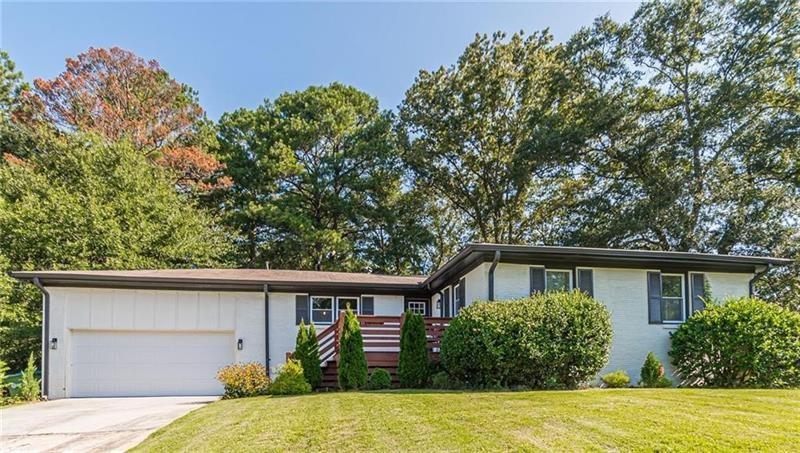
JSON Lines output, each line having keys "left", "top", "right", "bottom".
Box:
{"left": 70, "top": 331, "right": 235, "bottom": 397}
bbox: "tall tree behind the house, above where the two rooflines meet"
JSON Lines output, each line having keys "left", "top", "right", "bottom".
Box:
{"left": 400, "top": 33, "right": 581, "bottom": 243}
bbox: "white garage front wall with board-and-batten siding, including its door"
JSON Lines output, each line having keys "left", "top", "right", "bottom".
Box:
{"left": 48, "top": 288, "right": 271, "bottom": 399}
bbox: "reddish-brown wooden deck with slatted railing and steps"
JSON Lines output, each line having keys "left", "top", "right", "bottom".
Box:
{"left": 290, "top": 315, "right": 452, "bottom": 388}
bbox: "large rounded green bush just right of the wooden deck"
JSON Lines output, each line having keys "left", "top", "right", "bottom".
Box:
{"left": 441, "top": 291, "right": 612, "bottom": 389}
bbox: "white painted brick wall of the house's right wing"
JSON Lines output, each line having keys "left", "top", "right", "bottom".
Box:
{"left": 456, "top": 263, "right": 753, "bottom": 382}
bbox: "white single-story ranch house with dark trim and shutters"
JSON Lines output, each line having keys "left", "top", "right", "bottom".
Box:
{"left": 11, "top": 244, "right": 791, "bottom": 399}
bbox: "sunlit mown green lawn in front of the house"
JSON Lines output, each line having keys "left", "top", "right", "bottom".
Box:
{"left": 137, "top": 389, "right": 800, "bottom": 451}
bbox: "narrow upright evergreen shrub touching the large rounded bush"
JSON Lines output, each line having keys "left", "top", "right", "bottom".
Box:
{"left": 397, "top": 311, "right": 430, "bottom": 388}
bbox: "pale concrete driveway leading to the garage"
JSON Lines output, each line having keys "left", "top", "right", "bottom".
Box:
{"left": 0, "top": 396, "right": 217, "bottom": 452}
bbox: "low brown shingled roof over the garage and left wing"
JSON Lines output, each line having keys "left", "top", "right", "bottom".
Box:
{"left": 11, "top": 269, "right": 425, "bottom": 286}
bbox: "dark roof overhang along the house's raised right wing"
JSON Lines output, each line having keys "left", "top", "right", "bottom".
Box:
{"left": 423, "top": 244, "right": 793, "bottom": 290}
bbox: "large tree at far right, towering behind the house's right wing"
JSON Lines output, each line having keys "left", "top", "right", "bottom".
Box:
{"left": 564, "top": 0, "right": 800, "bottom": 254}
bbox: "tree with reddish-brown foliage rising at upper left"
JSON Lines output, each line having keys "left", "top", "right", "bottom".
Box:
{"left": 21, "top": 47, "right": 226, "bottom": 190}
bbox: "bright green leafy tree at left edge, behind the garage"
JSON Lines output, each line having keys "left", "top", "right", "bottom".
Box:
{"left": 0, "top": 134, "right": 226, "bottom": 367}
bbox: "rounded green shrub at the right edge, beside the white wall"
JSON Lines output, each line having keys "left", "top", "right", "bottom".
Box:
{"left": 669, "top": 297, "right": 800, "bottom": 388}
